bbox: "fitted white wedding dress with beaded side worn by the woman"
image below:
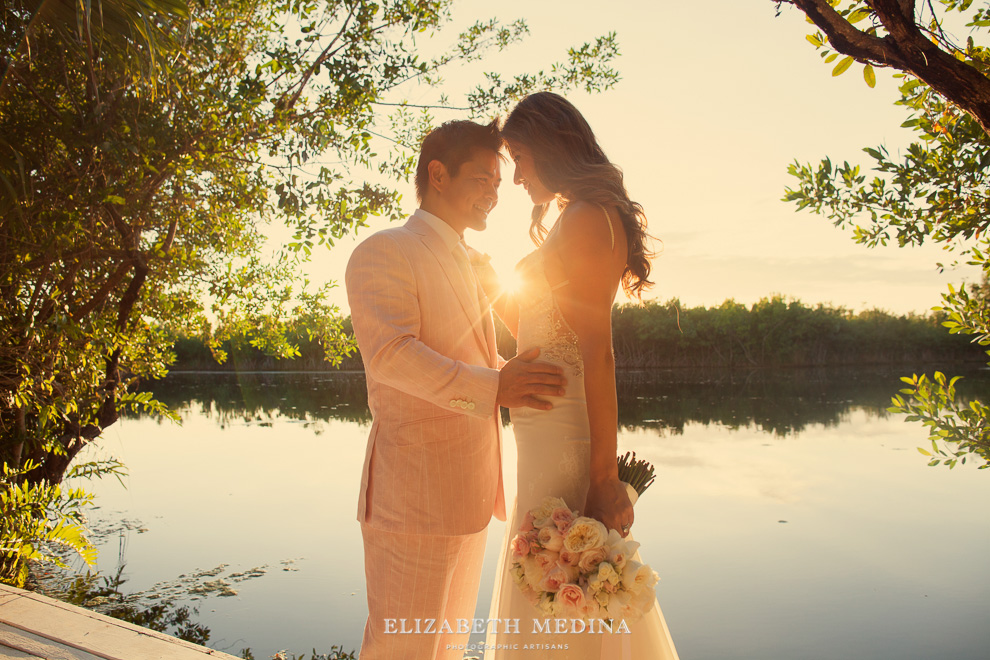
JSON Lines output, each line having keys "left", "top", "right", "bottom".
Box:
{"left": 483, "top": 240, "right": 677, "bottom": 660}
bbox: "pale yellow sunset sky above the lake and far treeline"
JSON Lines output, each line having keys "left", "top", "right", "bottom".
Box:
{"left": 302, "top": 0, "right": 978, "bottom": 313}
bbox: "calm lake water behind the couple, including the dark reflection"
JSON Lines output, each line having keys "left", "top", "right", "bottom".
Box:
{"left": 71, "top": 369, "right": 990, "bottom": 660}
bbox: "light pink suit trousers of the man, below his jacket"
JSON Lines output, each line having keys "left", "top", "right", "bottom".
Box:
{"left": 360, "top": 523, "right": 488, "bottom": 660}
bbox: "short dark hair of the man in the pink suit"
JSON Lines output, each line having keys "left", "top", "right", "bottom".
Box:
{"left": 416, "top": 119, "right": 502, "bottom": 202}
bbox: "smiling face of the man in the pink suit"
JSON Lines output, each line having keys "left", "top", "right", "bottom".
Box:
{"left": 439, "top": 149, "right": 502, "bottom": 231}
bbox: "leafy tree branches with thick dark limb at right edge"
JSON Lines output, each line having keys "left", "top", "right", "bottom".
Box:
{"left": 778, "top": 0, "right": 990, "bottom": 467}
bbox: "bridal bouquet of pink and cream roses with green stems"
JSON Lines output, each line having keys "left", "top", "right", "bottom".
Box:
{"left": 509, "top": 454, "right": 660, "bottom": 623}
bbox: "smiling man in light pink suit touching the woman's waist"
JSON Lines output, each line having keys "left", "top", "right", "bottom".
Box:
{"left": 345, "top": 121, "right": 563, "bottom": 660}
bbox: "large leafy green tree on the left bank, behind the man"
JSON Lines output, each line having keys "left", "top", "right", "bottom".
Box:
{"left": 0, "top": 0, "right": 617, "bottom": 496}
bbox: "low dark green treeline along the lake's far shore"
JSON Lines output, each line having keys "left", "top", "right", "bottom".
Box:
{"left": 172, "top": 296, "right": 987, "bottom": 371}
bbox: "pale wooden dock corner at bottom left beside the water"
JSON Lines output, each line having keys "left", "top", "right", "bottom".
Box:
{"left": 0, "top": 585, "right": 237, "bottom": 660}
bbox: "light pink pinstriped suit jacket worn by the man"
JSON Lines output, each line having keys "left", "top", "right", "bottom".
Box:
{"left": 345, "top": 215, "right": 505, "bottom": 535}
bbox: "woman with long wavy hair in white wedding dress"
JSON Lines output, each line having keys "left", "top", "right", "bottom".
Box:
{"left": 480, "top": 92, "right": 677, "bottom": 660}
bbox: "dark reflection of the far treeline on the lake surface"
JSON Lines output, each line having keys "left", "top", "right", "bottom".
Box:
{"left": 140, "top": 367, "right": 990, "bottom": 436}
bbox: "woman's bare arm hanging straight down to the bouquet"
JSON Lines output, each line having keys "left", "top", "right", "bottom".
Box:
{"left": 557, "top": 204, "right": 633, "bottom": 536}
